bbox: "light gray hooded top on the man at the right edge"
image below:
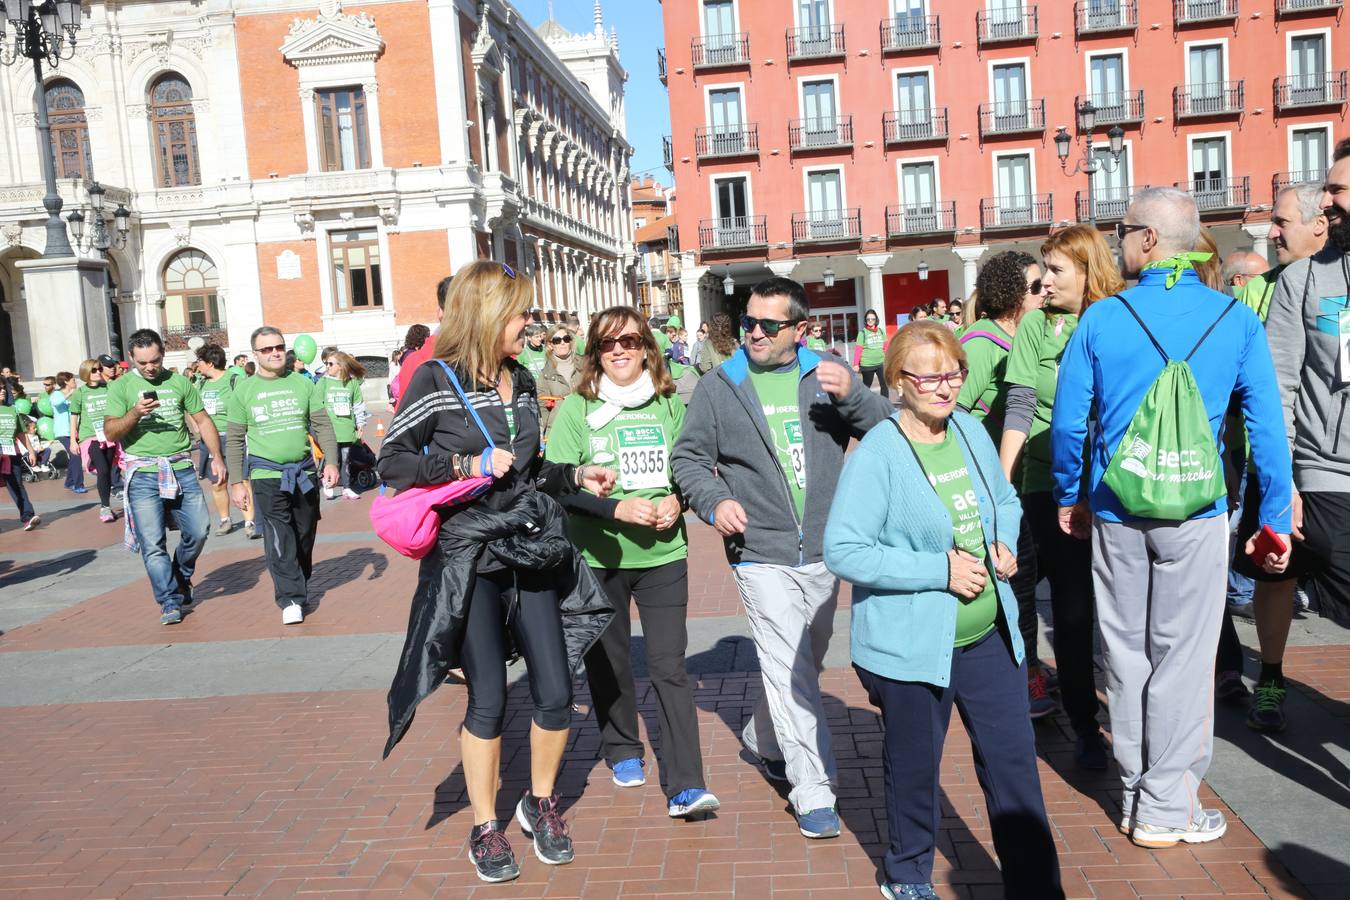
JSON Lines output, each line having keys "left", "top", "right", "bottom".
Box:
{"left": 1266, "top": 244, "right": 1350, "bottom": 493}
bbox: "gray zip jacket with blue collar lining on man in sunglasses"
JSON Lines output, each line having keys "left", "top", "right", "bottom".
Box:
{"left": 671, "top": 348, "right": 891, "bottom": 565}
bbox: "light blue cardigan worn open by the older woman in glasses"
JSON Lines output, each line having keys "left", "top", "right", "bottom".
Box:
{"left": 825, "top": 410, "right": 1023, "bottom": 687}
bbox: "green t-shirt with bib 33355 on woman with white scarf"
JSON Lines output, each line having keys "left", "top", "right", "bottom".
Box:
{"left": 544, "top": 394, "right": 689, "bottom": 569}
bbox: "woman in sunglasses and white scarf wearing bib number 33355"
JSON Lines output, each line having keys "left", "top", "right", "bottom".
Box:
{"left": 545, "top": 306, "right": 720, "bottom": 818}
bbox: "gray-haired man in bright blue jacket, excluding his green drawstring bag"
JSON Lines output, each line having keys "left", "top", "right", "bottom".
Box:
{"left": 1050, "top": 188, "right": 1292, "bottom": 847}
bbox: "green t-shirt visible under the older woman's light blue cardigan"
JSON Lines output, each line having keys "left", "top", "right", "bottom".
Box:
{"left": 911, "top": 429, "right": 999, "bottom": 646}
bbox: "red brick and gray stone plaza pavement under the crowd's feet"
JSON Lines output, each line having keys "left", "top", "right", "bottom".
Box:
{"left": 0, "top": 445, "right": 1350, "bottom": 900}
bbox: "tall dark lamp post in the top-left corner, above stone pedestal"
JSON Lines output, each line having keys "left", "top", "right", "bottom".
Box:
{"left": 0, "top": 0, "right": 80, "bottom": 259}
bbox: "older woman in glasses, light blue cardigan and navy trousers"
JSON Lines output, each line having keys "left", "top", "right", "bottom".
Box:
{"left": 825, "top": 322, "right": 1064, "bottom": 900}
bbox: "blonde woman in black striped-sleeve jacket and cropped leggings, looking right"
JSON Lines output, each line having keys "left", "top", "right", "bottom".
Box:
{"left": 379, "top": 260, "right": 614, "bottom": 881}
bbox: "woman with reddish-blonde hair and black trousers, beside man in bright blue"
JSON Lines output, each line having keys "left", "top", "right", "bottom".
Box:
{"left": 999, "top": 225, "right": 1125, "bottom": 770}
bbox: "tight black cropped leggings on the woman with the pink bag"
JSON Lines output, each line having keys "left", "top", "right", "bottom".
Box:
{"left": 460, "top": 572, "right": 572, "bottom": 741}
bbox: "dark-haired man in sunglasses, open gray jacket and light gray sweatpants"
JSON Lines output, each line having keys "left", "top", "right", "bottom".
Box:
{"left": 671, "top": 278, "right": 891, "bottom": 838}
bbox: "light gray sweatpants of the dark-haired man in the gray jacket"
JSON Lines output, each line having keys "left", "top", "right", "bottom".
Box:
{"left": 732, "top": 563, "right": 840, "bottom": 812}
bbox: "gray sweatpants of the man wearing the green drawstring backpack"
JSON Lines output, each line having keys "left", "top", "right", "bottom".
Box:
{"left": 1092, "top": 515, "right": 1229, "bottom": 828}
